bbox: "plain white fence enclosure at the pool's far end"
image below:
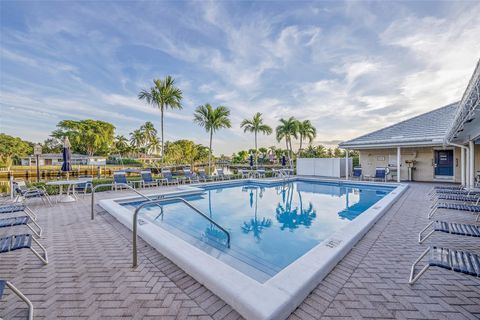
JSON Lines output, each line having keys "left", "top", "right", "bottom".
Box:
{"left": 297, "top": 158, "right": 352, "bottom": 178}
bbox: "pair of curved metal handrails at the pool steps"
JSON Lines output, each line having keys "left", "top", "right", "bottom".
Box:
{"left": 91, "top": 183, "right": 230, "bottom": 268}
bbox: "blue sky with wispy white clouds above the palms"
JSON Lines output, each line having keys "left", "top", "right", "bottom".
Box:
{"left": 0, "top": 1, "right": 480, "bottom": 154}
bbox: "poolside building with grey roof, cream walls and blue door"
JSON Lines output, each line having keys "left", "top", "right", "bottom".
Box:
{"left": 339, "top": 60, "right": 480, "bottom": 186}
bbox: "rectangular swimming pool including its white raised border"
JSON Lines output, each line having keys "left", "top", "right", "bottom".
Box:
{"left": 100, "top": 178, "right": 406, "bottom": 319}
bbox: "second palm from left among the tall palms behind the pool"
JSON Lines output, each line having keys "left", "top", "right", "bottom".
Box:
{"left": 193, "top": 103, "right": 232, "bottom": 172}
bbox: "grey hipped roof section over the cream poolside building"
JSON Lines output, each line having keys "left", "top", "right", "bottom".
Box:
{"left": 340, "top": 102, "right": 458, "bottom": 148}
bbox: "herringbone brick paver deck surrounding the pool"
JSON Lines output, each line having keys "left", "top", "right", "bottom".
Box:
{"left": 0, "top": 183, "right": 480, "bottom": 319}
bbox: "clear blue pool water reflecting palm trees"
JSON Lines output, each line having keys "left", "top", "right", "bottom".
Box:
{"left": 122, "top": 181, "right": 393, "bottom": 281}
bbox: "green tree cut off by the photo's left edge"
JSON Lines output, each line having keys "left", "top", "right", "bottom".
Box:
{"left": 0, "top": 133, "right": 33, "bottom": 170}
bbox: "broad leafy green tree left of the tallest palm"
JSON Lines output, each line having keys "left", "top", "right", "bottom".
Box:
{"left": 51, "top": 119, "right": 115, "bottom": 156}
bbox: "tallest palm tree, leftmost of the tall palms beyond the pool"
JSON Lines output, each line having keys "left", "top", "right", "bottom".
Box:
{"left": 138, "top": 76, "right": 183, "bottom": 162}
